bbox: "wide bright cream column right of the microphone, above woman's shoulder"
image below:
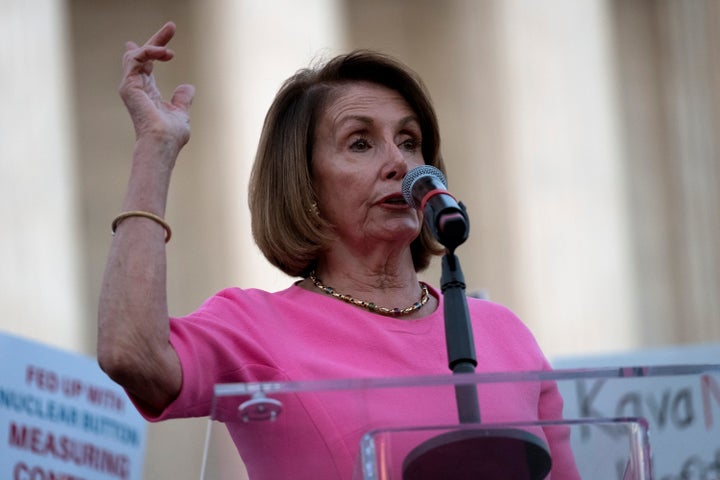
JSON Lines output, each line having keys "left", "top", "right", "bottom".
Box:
{"left": 499, "top": 0, "right": 638, "bottom": 353}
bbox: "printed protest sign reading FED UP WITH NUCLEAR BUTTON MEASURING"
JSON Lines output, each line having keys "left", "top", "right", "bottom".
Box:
{"left": 0, "top": 332, "right": 146, "bottom": 480}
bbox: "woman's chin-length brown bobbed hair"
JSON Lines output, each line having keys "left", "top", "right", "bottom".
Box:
{"left": 249, "top": 50, "right": 445, "bottom": 277}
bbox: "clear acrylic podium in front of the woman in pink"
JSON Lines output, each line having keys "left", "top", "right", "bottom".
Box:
{"left": 201, "top": 364, "right": 720, "bottom": 480}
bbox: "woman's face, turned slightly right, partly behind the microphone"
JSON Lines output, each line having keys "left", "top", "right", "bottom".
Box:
{"left": 312, "top": 82, "right": 424, "bottom": 248}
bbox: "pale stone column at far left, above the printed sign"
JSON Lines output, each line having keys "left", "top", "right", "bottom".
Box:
{"left": 0, "top": 0, "right": 88, "bottom": 352}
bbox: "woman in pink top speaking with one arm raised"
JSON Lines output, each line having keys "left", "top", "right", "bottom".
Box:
{"left": 98, "top": 23, "right": 572, "bottom": 479}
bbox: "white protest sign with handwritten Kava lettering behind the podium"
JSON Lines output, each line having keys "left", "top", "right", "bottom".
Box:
{"left": 553, "top": 345, "right": 720, "bottom": 480}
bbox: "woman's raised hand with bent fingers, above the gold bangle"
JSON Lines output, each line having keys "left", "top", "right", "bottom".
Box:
{"left": 118, "top": 22, "right": 195, "bottom": 151}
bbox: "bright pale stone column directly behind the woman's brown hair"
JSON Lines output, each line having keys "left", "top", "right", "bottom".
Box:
{"left": 192, "top": 0, "right": 343, "bottom": 290}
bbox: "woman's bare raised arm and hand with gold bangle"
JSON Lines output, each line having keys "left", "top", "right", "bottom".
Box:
{"left": 97, "top": 23, "right": 194, "bottom": 412}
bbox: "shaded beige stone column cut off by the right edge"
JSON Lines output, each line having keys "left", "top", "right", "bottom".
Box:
{"left": 662, "top": 1, "right": 720, "bottom": 343}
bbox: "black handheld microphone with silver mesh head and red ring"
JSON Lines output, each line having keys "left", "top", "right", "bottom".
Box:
{"left": 402, "top": 165, "right": 470, "bottom": 250}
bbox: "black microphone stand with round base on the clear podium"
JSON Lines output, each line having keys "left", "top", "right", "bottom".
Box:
{"left": 402, "top": 203, "right": 552, "bottom": 480}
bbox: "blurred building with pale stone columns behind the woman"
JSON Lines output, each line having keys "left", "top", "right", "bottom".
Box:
{"left": 0, "top": 0, "right": 720, "bottom": 478}
